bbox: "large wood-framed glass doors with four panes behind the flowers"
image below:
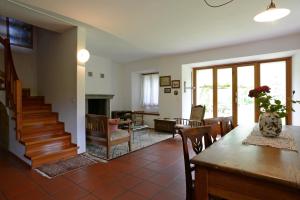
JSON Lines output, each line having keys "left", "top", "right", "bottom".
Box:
{"left": 193, "top": 58, "right": 292, "bottom": 125}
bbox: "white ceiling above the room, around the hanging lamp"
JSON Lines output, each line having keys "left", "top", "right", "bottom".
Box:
{"left": 4, "top": 0, "right": 300, "bottom": 62}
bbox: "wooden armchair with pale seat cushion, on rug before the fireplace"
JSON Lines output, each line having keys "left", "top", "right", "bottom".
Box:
{"left": 86, "top": 114, "right": 131, "bottom": 159}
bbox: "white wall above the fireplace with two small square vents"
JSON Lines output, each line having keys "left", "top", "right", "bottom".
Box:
{"left": 85, "top": 54, "right": 128, "bottom": 110}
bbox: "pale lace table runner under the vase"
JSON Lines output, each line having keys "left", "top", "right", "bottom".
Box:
{"left": 243, "top": 125, "right": 298, "bottom": 152}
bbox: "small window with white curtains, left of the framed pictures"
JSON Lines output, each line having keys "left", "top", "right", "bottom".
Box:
{"left": 141, "top": 73, "right": 159, "bottom": 109}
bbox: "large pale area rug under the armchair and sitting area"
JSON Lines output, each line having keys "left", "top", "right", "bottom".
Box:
{"left": 87, "top": 129, "right": 172, "bottom": 160}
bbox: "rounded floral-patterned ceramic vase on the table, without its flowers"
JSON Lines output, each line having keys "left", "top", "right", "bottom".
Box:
{"left": 259, "top": 112, "right": 282, "bottom": 137}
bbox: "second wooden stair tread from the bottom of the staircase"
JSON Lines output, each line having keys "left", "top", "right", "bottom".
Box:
{"left": 22, "top": 132, "right": 70, "bottom": 145}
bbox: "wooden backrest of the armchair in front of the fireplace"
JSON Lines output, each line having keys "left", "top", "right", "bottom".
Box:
{"left": 86, "top": 114, "right": 108, "bottom": 138}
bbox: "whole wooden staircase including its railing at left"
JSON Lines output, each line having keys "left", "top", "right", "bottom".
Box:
{"left": 0, "top": 37, "right": 77, "bottom": 168}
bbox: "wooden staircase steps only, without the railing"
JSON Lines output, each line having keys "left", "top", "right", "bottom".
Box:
{"left": 20, "top": 90, "right": 77, "bottom": 168}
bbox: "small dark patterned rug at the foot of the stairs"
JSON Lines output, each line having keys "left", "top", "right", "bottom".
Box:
{"left": 35, "top": 154, "right": 97, "bottom": 178}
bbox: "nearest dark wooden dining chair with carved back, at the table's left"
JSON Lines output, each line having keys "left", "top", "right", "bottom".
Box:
{"left": 180, "top": 126, "right": 211, "bottom": 200}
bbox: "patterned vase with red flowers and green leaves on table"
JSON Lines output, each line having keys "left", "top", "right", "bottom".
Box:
{"left": 248, "top": 86, "right": 300, "bottom": 137}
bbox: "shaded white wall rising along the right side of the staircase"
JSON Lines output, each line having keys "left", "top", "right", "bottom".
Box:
{"left": 37, "top": 28, "right": 82, "bottom": 148}
